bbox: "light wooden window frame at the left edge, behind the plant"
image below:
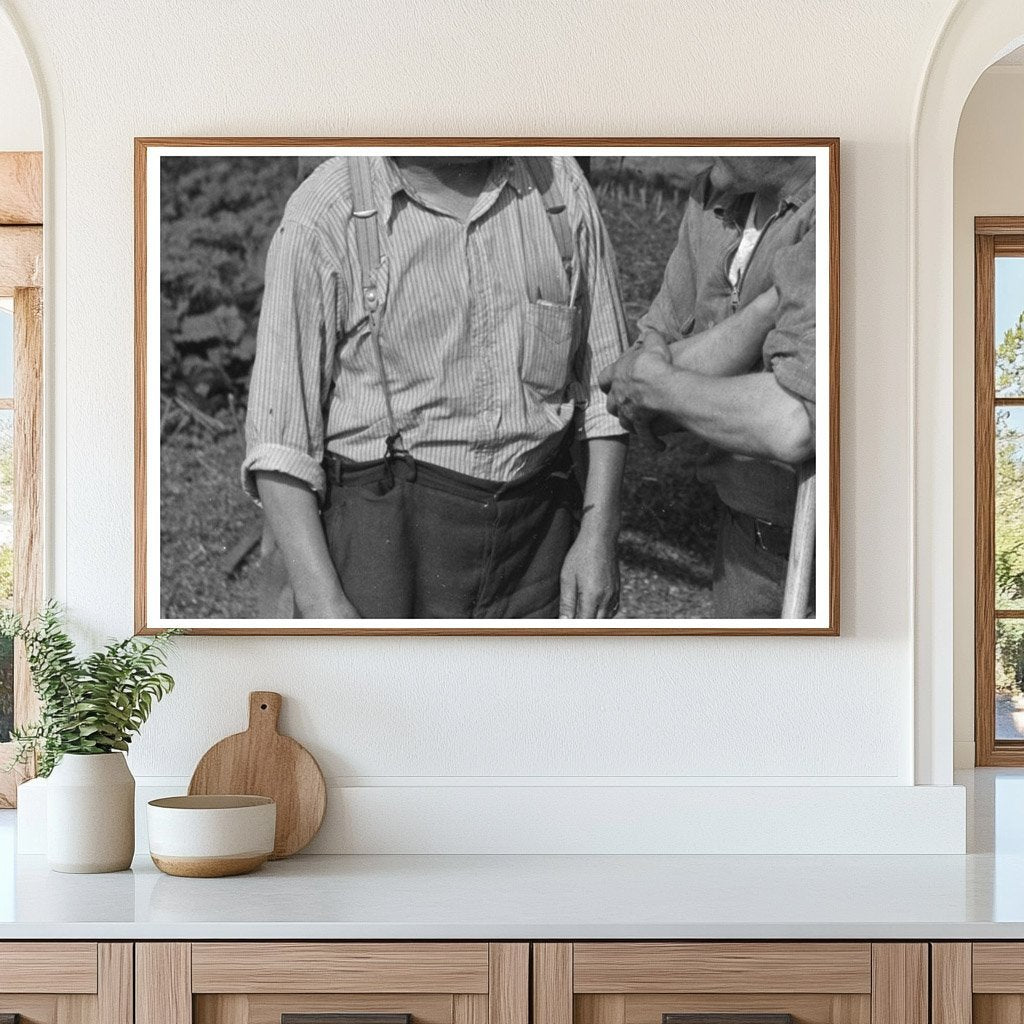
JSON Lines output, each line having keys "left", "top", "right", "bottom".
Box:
{"left": 0, "top": 153, "right": 43, "bottom": 807}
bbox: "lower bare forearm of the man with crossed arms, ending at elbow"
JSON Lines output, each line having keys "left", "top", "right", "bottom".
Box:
{"left": 643, "top": 368, "right": 814, "bottom": 464}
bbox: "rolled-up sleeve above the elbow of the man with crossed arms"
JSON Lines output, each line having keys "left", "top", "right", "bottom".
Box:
{"left": 763, "top": 219, "right": 817, "bottom": 427}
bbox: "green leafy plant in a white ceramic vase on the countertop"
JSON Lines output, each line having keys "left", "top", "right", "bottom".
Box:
{"left": 0, "top": 602, "right": 178, "bottom": 872}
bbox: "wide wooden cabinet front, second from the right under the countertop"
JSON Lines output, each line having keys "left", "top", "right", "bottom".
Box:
{"left": 534, "top": 942, "right": 928, "bottom": 1024}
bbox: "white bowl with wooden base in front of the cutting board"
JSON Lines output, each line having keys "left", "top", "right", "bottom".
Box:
{"left": 146, "top": 795, "right": 278, "bottom": 879}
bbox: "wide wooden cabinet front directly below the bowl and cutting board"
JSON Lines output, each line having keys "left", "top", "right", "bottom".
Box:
{"left": 136, "top": 942, "right": 529, "bottom": 1024}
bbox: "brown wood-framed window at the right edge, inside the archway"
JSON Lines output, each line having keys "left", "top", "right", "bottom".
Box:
{"left": 975, "top": 217, "right": 1024, "bottom": 765}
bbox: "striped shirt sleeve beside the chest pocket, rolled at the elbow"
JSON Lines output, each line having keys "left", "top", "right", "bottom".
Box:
{"left": 570, "top": 168, "right": 629, "bottom": 439}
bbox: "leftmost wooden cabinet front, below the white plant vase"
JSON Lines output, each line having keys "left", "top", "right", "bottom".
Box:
{"left": 0, "top": 942, "right": 132, "bottom": 1024}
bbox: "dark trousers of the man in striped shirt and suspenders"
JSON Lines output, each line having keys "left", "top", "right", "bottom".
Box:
{"left": 324, "top": 460, "right": 580, "bottom": 618}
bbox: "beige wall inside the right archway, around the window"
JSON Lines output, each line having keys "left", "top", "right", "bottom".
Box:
{"left": 953, "top": 65, "right": 1024, "bottom": 767}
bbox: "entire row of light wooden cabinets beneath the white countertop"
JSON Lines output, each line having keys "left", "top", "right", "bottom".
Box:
{"left": 0, "top": 942, "right": 974, "bottom": 1024}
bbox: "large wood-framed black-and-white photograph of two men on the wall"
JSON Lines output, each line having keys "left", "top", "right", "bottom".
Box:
{"left": 135, "top": 138, "right": 839, "bottom": 636}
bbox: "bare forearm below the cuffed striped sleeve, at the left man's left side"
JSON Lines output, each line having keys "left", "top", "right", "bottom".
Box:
{"left": 256, "top": 472, "right": 357, "bottom": 618}
